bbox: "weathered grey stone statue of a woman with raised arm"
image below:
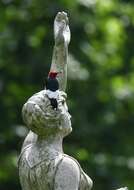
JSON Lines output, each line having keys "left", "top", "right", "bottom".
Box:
{"left": 19, "top": 12, "right": 92, "bottom": 190}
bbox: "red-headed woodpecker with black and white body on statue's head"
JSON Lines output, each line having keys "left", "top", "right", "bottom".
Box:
{"left": 46, "top": 71, "right": 59, "bottom": 110}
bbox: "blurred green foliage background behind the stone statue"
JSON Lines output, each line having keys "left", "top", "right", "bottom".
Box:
{"left": 0, "top": 0, "right": 134, "bottom": 190}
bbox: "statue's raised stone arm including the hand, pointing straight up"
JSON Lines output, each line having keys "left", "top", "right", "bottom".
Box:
{"left": 50, "top": 12, "right": 70, "bottom": 91}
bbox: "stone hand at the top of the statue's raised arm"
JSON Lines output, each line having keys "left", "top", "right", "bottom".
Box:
{"left": 54, "top": 11, "right": 70, "bottom": 45}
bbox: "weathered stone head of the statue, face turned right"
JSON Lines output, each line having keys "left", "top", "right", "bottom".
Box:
{"left": 22, "top": 90, "right": 72, "bottom": 136}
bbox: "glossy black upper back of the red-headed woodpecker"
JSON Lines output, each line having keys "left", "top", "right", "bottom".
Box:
{"left": 46, "top": 77, "right": 59, "bottom": 92}
